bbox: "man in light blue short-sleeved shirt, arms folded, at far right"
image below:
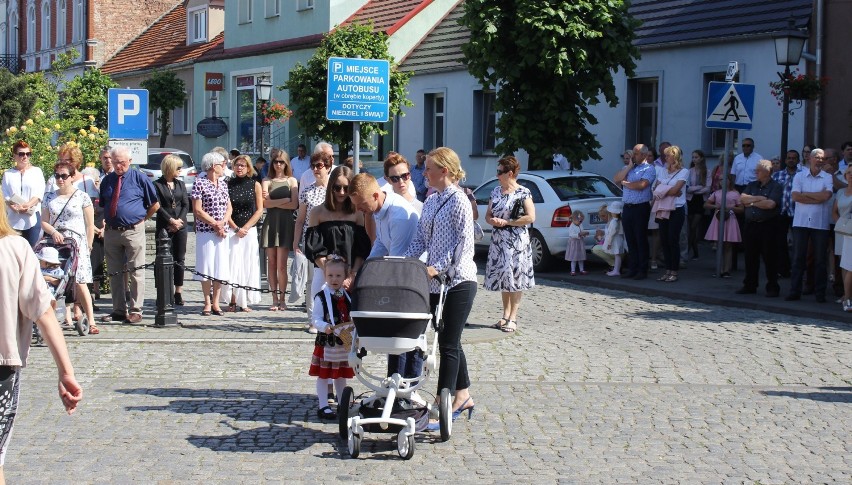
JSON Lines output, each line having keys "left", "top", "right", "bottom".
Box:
{"left": 785, "top": 148, "right": 834, "bottom": 303}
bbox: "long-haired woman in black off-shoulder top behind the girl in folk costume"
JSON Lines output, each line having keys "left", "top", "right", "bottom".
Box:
{"left": 305, "top": 162, "right": 370, "bottom": 333}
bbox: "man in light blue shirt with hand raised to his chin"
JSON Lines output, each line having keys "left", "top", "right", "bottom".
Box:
{"left": 613, "top": 143, "right": 657, "bottom": 280}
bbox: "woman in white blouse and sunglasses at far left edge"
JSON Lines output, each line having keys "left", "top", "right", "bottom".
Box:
{"left": 2, "top": 140, "right": 45, "bottom": 246}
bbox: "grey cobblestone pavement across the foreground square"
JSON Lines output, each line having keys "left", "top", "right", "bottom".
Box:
{"left": 5, "top": 233, "right": 852, "bottom": 484}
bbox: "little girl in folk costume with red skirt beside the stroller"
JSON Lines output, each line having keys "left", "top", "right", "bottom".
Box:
{"left": 308, "top": 254, "right": 355, "bottom": 420}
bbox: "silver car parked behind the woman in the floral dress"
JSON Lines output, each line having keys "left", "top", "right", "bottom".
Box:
{"left": 473, "top": 170, "right": 621, "bottom": 271}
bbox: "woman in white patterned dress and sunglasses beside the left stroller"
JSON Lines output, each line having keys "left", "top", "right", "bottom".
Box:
{"left": 41, "top": 162, "right": 100, "bottom": 334}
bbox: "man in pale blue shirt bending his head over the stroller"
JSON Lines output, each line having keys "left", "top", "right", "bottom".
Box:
{"left": 349, "top": 173, "right": 423, "bottom": 384}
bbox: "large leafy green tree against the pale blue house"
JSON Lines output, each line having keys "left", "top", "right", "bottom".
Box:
{"left": 460, "top": 0, "right": 639, "bottom": 168}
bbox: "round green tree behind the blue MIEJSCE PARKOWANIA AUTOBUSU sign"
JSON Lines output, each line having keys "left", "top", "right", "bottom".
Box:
{"left": 278, "top": 24, "right": 412, "bottom": 153}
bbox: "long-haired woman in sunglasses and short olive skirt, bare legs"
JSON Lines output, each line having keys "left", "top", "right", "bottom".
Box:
{"left": 261, "top": 148, "right": 299, "bottom": 311}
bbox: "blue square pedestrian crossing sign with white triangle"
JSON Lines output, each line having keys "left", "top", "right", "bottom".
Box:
{"left": 706, "top": 81, "right": 754, "bottom": 130}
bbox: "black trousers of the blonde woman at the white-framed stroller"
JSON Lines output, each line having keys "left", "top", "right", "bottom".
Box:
{"left": 430, "top": 281, "right": 476, "bottom": 394}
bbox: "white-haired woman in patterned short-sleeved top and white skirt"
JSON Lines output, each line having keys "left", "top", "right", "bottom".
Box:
{"left": 190, "top": 152, "right": 232, "bottom": 316}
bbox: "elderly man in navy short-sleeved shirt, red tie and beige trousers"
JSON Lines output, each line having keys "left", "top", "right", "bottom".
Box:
{"left": 100, "top": 147, "right": 160, "bottom": 323}
